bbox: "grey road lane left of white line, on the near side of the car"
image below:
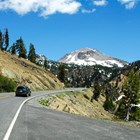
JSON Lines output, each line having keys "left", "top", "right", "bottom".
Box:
{"left": 0, "top": 93, "right": 25, "bottom": 140}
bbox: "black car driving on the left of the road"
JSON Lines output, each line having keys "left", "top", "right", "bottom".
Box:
{"left": 15, "top": 86, "right": 31, "bottom": 97}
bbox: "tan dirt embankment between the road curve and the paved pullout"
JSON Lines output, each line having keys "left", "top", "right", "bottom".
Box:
{"left": 39, "top": 89, "right": 113, "bottom": 120}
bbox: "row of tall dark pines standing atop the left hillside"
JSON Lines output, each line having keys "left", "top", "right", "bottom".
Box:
{"left": 0, "top": 28, "right": 36, "bottom": 63}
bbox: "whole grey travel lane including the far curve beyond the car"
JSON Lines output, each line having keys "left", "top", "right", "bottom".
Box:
{"left": 0, "top": 88, "right": 82, "bottom": 140}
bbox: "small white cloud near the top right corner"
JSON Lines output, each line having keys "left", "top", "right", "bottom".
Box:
{"left": 118, "top": 0, "right": 138, "bottom": 9}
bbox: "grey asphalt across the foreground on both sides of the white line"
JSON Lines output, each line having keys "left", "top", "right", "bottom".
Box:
{"left": 0, "top": 91, "right": 140, "bottom": 140}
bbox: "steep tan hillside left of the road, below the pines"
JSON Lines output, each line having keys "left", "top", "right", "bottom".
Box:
{"left": 0, "top": 51, "right": 63, "bottom": 90}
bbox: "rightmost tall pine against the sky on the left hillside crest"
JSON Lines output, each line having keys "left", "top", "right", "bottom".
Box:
{"left": 28, "top": 43, "right": 36, "bottom": 63}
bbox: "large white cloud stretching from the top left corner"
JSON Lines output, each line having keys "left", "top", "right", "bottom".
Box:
{"left": 0, "top": 0, "right": 81, "bottom": 17}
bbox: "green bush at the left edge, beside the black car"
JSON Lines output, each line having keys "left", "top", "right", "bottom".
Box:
{"left": 0, "top": 75, "right": 16, "bottom": 92}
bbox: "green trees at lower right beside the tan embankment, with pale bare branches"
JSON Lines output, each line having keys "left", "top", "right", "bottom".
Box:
{"left": 91, "top": 69, "right": 140, "bottom": 121}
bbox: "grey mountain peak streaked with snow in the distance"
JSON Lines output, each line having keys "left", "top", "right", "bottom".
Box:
{"left": 59, "top": 48, "right": 127, "bottom": 67}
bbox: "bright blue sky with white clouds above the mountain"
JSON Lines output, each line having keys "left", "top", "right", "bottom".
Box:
{"left": 0, "top": 0, "right": 140, "bottom": 62}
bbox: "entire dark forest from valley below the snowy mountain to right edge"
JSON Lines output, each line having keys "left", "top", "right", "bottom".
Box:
{"left": 49, "top": 61, "right": 140, "bottom": 121}
